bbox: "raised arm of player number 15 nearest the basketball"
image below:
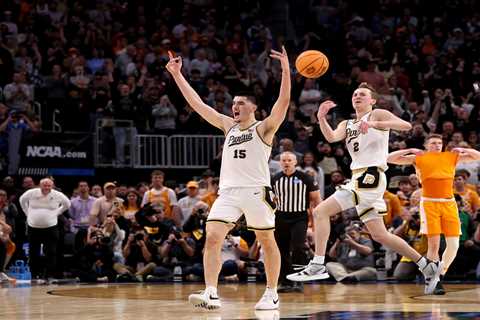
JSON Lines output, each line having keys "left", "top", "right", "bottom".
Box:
{"left": 258, "top": 47, "right": 292, "bottom": 142}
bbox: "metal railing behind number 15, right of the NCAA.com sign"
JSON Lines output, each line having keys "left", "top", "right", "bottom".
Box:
{"left": 94, "top": 119, "right": 225, "bottom": 169}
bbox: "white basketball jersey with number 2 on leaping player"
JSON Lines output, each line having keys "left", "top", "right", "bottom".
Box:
{"left": 345, "top": 112, "right": 389, "bottom": 170}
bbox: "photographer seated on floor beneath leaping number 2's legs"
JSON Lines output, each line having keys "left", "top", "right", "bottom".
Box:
{"left": 326, "top": 224, "right": 377, "bottom": 282}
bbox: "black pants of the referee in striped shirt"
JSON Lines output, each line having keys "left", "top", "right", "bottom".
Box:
{"left": 275, "top": 211, "right": 308, "bottom": 284}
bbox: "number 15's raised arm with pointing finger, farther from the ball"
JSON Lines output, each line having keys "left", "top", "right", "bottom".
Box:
{"left": 166, "top": 51, "right": 234, "bottom": 132}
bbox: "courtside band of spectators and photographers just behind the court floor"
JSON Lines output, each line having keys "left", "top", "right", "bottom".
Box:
{"left": 0, "top": 167, "right": 480, "bottom": 282}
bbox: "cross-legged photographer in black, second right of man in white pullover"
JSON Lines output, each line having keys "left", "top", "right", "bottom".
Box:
{"left": 113, "top": 230, "right": 157, "bottom": 282}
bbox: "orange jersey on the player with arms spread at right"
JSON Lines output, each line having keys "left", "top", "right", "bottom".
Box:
{"left": 415, "top": 151, "right": 458, "bottom": 199}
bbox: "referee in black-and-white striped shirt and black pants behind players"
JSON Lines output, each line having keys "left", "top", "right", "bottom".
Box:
{"left": 272, "top": 151, "right": 321, "bottom": 292}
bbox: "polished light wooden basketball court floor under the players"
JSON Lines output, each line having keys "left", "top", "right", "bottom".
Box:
{"left": 0, "top": 283, "right": 480, "bottom": 320}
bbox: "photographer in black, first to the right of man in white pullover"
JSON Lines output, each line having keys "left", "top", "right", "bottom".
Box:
{"left": 73, "top": 226, "right": 115, "bottom": 282}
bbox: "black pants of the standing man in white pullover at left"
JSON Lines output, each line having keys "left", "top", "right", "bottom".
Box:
{"left": 28, "top": 226, "right": 59, "bottom": 278}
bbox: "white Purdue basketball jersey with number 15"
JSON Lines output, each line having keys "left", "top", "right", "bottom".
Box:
{"left": 220, "top": 122, "right": 272, "bottom": 189}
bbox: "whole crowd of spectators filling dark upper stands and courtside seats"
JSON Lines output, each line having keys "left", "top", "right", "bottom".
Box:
{"left": 0, "top": 0, "right": 480, "bottom": 281}
